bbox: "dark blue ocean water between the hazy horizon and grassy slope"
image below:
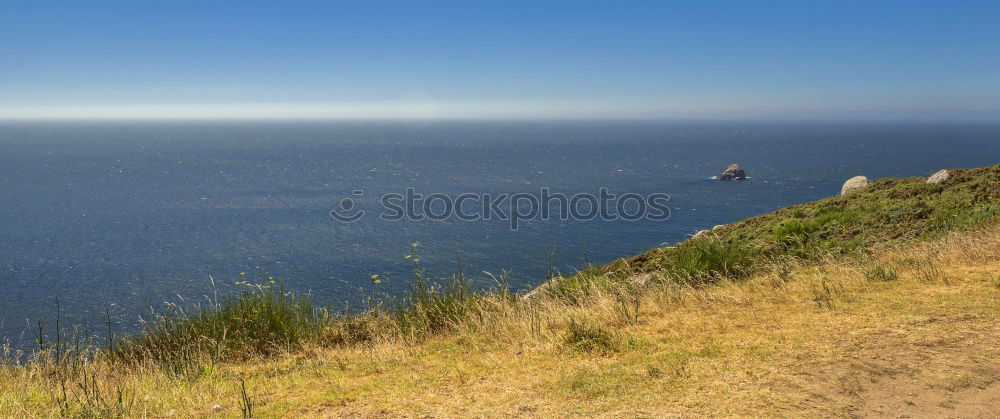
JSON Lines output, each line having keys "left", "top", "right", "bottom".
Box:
{"left": 0, "top": 122, "right": 1000, "bottom": 345}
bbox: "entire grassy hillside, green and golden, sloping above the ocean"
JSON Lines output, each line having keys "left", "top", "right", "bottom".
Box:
{"left": 0, "top": 166, "right": 1000, "bottom": 417}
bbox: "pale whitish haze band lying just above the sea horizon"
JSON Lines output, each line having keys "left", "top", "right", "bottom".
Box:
{"left": 0, "top": 99, "right": 1000, "bottom": 121}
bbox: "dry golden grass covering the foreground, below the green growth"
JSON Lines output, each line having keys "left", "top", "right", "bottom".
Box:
{"left": 0, "top": 227, "right": 1000, "bottom": 417}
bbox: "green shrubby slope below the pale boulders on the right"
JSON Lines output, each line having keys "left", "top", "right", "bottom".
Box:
{"left": 548, "top": 165, "right": 1000, "bottom": 298}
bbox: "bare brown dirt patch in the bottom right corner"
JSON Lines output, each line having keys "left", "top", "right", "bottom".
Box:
{"left": 784, "top": 315, "right": 1000, "bottom": 418}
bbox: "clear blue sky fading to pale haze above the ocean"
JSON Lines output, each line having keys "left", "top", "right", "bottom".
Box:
{"left": 0, "top": 0, "right": 1000, "bottom": 119}
